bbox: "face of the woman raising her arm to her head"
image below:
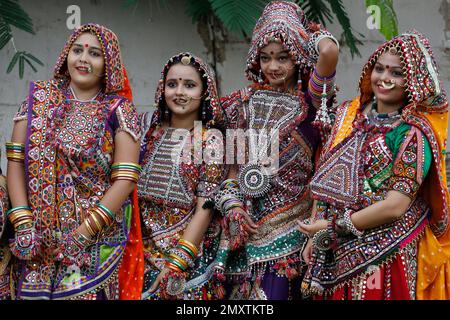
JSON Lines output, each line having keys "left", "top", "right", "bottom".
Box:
{"left": 259, "top": 42, "right": 296, "bottom": 88}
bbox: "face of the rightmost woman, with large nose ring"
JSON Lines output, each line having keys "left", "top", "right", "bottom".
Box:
{"left": 370, "top": 52, "right": 406, "bottom": 110}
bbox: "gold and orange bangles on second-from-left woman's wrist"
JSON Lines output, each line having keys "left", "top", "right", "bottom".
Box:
{"left": 166, "top": 239, "right": 198, "bottom": 272}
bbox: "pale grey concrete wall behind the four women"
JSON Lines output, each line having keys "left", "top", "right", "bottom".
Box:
{"left": 0, "top": 0, "right": 450, "bottom": 171}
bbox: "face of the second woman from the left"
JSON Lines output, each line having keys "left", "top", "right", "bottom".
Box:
{"left": 164, "top": 63, "right": 203, "bottom": 117}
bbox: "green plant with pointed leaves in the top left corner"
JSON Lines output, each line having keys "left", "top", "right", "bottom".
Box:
{"left": 0, "top": 0, "right": 44, "bottom": 79}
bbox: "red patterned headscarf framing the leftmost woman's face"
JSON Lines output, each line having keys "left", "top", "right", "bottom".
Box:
{"left": 54, "top": 23, "right": 125, "bottom": 96}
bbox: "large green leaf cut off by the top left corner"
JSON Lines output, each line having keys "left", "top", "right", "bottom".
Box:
{"left": 0, "top": 0, "right": 34, "bottom": 34}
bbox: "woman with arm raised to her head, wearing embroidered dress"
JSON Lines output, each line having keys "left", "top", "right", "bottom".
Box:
{"left": 215, "top": 1, "right": 339, "bottom": 300}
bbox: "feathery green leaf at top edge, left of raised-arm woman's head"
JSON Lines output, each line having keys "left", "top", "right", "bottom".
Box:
{"left": 209, "top": 0, "right": 269, "bottom": 36}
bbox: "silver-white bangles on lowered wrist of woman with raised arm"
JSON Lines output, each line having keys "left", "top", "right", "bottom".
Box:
{"left": 214, "top": 179, "right": 244, "bottom": 214}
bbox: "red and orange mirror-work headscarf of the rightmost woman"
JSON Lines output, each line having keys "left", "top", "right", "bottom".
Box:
{"left": 359, "top": 30, "right": 450, "bottom": 237}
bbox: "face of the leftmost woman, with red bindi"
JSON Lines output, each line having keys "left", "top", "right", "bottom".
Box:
{"left": 67, "top": 32, "right": 105, "bottom": 90}
